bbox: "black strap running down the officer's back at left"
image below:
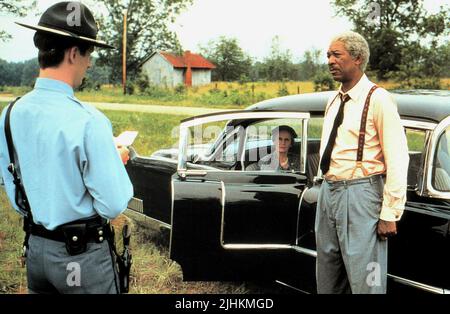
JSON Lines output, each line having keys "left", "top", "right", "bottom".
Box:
{"left": 5, "top": 97, "right": 32, "bottom": 219}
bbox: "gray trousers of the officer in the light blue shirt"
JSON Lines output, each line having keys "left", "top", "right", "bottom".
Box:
{"left": 26, "top": 235, "right": 119, "bottom": 294}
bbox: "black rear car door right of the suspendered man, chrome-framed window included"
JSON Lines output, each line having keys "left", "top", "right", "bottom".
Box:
{"left": 388, "top": 117, "right": 450, "bottom": 293}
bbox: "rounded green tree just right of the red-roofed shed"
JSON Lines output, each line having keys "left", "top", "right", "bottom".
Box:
{"left": 199, "top": 36, "right": 252, "bottom": 81}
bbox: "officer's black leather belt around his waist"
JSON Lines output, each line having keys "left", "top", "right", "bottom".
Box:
{"left": 29, "top": 216, "right": 111, "bottom": 243}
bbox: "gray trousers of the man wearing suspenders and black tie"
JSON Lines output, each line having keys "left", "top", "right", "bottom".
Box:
{"left": 315, "top": 176, "right": 387, "bottom": 293}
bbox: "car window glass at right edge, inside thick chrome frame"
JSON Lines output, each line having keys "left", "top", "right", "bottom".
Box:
{"left": 432, "top": 127, "right": 450, "bottom": 192}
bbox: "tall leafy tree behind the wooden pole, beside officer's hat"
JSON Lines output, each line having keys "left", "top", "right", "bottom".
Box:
{"left": 97, "top": 0, "right": 192, "bottom": 82}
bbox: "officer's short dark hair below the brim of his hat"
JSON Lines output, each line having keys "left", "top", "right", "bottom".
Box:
{"left": 33, "top": 31, "right": 93, "bottom": 69}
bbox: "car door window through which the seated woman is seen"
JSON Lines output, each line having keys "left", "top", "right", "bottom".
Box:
{"left": 243, "top": 119, "right": 302, "bottom": 172}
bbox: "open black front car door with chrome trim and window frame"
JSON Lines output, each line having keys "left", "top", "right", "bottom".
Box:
{"left": 170, "top": 111, "right": 309, "bottom": 280}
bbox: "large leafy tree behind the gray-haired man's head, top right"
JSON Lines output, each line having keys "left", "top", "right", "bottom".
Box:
{"left": 333, "top": 0, "right": 450, "bottom": 79}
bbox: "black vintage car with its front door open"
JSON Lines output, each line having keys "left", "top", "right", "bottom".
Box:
{"left": 127, "top": 91, "right": 450, "bottom": 293}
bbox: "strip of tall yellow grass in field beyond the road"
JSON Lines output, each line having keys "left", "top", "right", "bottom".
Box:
{"left": 5, "top": 78, "right": 450, "bottom": 109}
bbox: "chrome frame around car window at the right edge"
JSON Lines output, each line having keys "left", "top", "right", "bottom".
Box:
{"left": 425, "top": 116, "right": 450, "bottom": 199}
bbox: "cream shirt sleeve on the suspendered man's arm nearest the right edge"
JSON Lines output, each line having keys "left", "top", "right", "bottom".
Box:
{"left": 374, "top": 89, "right": 409, "bottom": 221}
